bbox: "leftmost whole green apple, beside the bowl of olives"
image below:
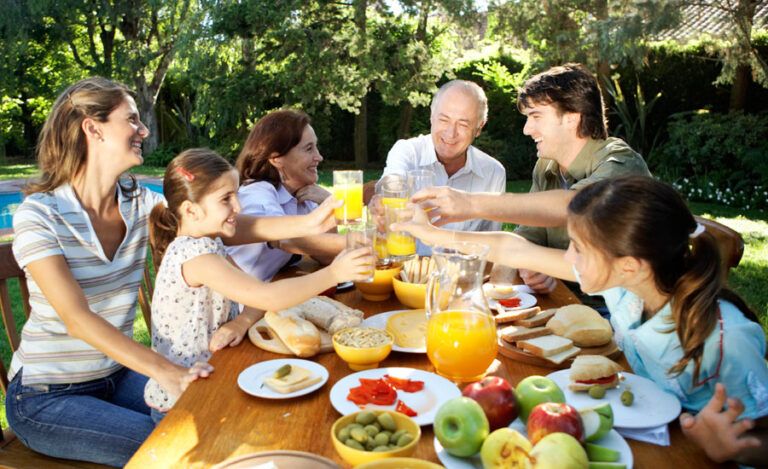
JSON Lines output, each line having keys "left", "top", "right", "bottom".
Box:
{"left": 433, "top": 396, "right": 490, "bottom": 458}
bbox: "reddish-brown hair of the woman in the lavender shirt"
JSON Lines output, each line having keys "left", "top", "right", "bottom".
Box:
{"left": 236, "top": 109, "right": 311, "bottom": 187}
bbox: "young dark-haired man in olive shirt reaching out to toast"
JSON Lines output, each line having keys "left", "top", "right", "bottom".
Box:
{"left": 414, "top": 64, "right": 650, "bottom": 293}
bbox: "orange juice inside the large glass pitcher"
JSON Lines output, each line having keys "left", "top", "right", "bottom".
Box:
{"left": 427, "top": 310, "right": 497, "bottom": 382}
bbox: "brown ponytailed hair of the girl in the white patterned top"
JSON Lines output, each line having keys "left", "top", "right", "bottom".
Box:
{"left": 149, "top": 148, "right": 234, "bottom": 265}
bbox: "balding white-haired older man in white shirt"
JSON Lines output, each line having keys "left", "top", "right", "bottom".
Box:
{"left": 368, "top": 80, "right": 507, "bottom": 236}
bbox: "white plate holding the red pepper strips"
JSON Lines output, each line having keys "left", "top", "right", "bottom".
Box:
{"left": 331, "top": 368, "right": 461, "bottom": 425}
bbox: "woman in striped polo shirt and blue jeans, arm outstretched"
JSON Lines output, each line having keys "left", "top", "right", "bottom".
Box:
{"left": 6, "top": 78, "right": 338, "bottom": 466}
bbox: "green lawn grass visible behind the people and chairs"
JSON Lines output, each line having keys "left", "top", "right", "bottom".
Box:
{"left": 0, "top": 171, "right": 768, "bottom": 427}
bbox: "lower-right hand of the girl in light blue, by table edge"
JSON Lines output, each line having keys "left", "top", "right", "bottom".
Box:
{"left": 680, "top": 383, "right": 760, "bottom": 462}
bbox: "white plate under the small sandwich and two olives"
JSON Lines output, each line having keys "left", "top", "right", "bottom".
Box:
{"left": 547, "top": 370, "right": 680, "bottom": 428}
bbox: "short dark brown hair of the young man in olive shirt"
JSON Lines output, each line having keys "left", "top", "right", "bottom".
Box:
{"left": 517, "top": 63, "right": 608, "bottom": 140}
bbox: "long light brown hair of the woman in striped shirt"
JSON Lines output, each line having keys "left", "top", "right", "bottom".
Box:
{"left": 24, "top": 77, "right": 138, "bottom": 195}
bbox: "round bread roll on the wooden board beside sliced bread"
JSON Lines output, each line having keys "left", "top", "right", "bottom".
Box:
{"left": 547, "top": 305, "right": 613, "bottom": 347}
